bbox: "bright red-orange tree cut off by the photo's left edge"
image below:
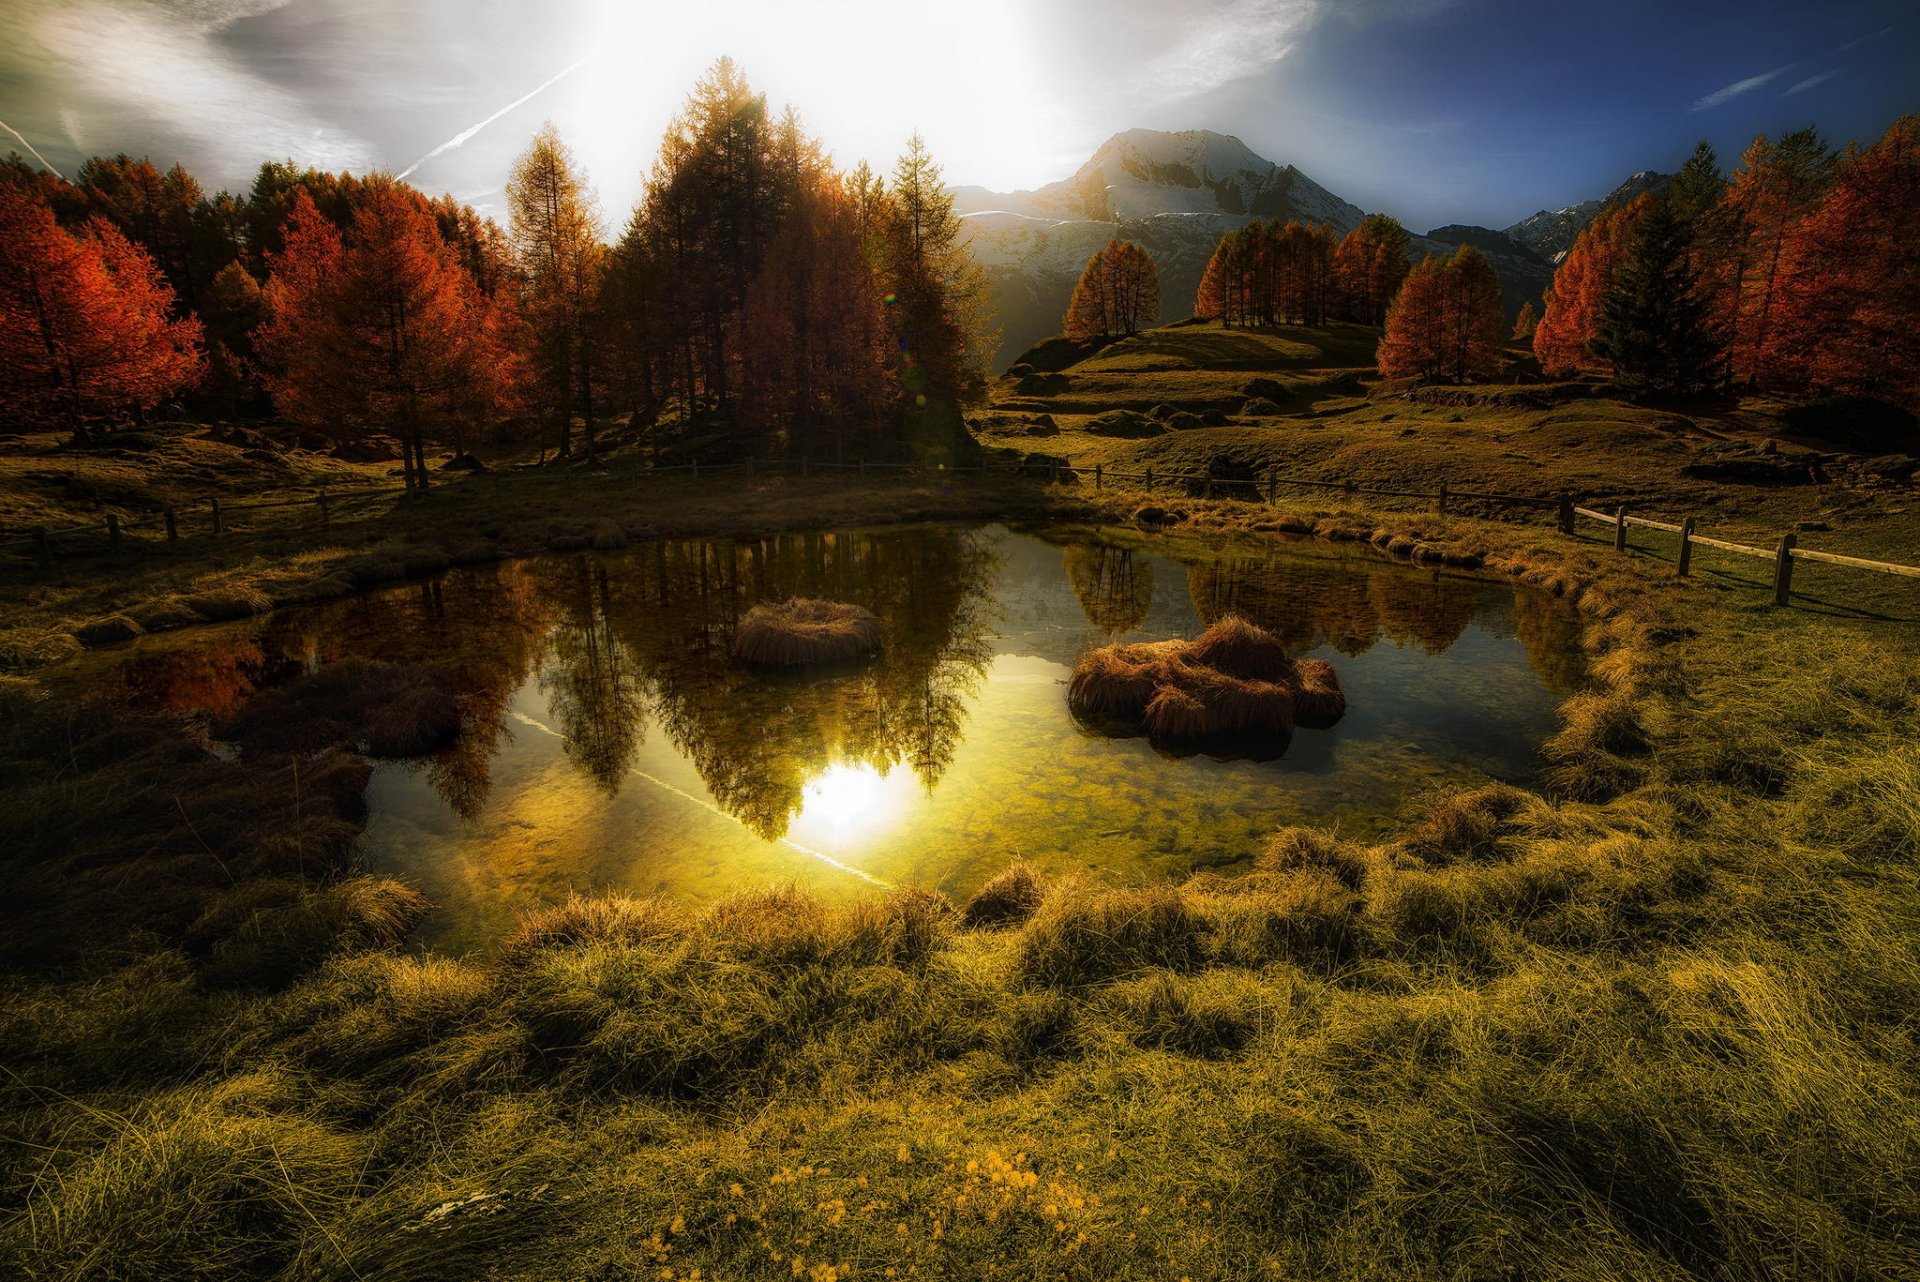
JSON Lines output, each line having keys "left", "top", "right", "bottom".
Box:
{"left": 0, "top": 186, "right": 205, "bottom": 434}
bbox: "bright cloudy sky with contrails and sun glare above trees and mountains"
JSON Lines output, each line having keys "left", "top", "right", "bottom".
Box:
{"left": 0, "top": 0, "right": 1920, "bottom": 230}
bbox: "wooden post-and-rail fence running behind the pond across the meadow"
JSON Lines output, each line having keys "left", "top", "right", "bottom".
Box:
{"left": 0, "top": 457, "right": 1920, "bottom": 605}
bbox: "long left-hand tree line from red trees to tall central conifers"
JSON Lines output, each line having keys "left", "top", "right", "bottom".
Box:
{"left": 0, "top": 59, "right": 991, "bottom": 470}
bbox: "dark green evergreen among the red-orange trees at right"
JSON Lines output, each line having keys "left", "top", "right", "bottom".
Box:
{"left": 1592, "top": 200, "right": 1724, "bottom": 395}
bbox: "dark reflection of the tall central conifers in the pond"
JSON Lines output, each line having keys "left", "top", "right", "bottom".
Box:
{"left": 541, "top": 530, "right": 993, "bottom": 837}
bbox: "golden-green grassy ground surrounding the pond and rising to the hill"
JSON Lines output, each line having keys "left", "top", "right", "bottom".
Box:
{"left": 0, "top": 328, "right": 1920, "bottom": 1282}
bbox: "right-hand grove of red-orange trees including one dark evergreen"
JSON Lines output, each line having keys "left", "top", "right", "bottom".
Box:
{"left": 1534, "top": 115, "right": 1920, "bottom": 403}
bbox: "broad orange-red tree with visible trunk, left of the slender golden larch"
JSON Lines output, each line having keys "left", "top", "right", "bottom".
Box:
{"left": 255, "top": 178, "right": 501, "bottom": 491}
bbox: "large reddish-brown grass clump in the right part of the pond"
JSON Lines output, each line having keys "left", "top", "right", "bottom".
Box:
{"left": 1068, "top": 614, "right": 1346, "bottom": 743}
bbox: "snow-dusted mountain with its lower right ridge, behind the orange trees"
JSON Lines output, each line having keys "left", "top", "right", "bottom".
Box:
{"left": 954, "top": 129, "right": 1543, "bottom": 368}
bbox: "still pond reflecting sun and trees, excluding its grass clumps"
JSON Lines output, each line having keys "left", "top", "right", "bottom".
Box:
{"left": 82, "top": 526, "right": 1584, "bottom": 952}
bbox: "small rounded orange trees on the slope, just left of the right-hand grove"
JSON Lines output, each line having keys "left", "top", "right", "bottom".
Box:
{"left": 1379, "top": 246, "right": 1505, "bottom": 382}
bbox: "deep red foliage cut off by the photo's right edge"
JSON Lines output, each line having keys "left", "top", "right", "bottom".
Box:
{"left": 1759, "top": 115, "right": 1920, "bottom": 401}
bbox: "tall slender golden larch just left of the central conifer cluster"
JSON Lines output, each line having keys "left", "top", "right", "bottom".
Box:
{"left": 507, "top": 121, "right": 605, "bottom": 459}
